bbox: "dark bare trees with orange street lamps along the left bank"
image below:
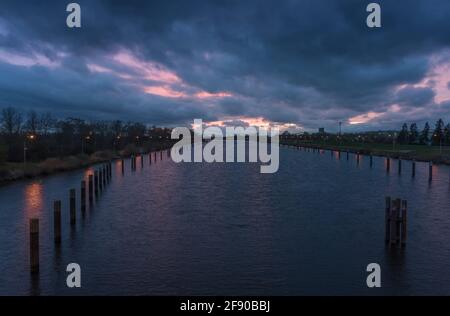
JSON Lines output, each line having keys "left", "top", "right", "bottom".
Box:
{"left": 0, "top": 107, "right": 171, "bottom": 163}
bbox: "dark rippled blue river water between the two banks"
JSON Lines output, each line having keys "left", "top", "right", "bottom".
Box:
{"left": 0, "top": 149, "right": 450, "bottom": 295}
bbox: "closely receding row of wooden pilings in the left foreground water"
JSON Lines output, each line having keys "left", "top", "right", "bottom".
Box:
{"left": 30, "top": 162, "right": 112, "bottom": 273}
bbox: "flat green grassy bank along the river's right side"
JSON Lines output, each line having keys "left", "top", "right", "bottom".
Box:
{"left": 280, "top": 140, "right": 450, "bottom": 165}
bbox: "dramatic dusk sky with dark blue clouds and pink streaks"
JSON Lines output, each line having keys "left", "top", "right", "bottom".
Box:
{"left": 0, "top": 0, "right": 450, "bottom": 131}
